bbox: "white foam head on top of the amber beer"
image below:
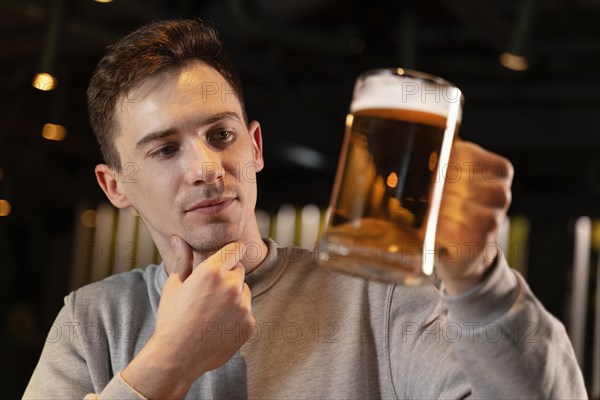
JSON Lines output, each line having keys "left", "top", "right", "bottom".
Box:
{"left": 350, "top": 72, "right": 462, "bottom": 122}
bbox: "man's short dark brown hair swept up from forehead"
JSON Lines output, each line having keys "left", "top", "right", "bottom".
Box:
{"left": 87, "top": 20, "right": 245, "bottom": 171}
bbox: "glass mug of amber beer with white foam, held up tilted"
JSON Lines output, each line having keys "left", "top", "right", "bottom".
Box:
{"left": 318, "top": 68, "right": 463, "bottom": 285}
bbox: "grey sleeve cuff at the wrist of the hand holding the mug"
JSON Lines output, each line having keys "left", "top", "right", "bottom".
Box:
{"left": 442, "top": 254, "right": 518, "bottom": 322}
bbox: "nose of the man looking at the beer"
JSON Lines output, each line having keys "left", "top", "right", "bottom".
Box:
{"left": 186, "top": 140, "right": 223, "bottom": 185}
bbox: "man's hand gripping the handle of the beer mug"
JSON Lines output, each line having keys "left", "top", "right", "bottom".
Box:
{"left": 436, "top": 139, "right": 513, "bottom": 294}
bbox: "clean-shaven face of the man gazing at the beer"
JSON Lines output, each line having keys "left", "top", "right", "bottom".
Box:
{"left": 105, "top": 62, "right": 263, "bottom": 252}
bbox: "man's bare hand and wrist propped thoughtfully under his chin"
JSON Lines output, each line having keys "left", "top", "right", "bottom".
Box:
{"left": 121, "top": 236, "right": 255, "bottom": 398}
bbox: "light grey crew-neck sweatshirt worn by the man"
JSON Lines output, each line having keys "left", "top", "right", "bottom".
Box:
{"left": 24, "top": 242, "right": 586, "bottom": 399}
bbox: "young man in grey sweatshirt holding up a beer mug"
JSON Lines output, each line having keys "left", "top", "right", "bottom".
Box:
{"left": 25, "top": 21, "right": 586, "bottom": 399}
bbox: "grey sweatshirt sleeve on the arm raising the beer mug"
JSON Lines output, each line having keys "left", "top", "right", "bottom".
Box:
{"left": 442, "top": 257, "right": 587, "bottom": 399}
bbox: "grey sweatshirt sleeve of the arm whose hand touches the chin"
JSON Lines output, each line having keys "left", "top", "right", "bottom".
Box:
{"left": 23, "top": 297, "right": 144, "bottom": 400}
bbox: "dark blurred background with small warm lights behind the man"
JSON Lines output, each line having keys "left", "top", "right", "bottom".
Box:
{"left": 0, "top": 0, "right": 600, "bottom": 398}
